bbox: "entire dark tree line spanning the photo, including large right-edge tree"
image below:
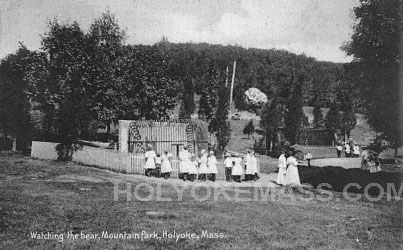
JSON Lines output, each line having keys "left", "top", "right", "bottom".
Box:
{"left": 0, "top": 0, "right": 401, "bottom": 156}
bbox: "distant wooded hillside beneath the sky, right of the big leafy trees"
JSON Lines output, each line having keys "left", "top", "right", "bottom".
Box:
{"left": 163, "top": 43, "right": 344, "bottom": 110}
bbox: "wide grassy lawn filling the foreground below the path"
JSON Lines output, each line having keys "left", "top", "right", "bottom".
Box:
{"left": 0, "top": 155, "right": 403, "bottom": 249}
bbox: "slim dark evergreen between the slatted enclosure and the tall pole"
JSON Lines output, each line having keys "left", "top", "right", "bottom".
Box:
{"left": 208, "top": 82, "right": 231, "bottom": 152}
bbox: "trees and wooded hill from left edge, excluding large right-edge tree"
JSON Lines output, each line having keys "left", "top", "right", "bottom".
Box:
{"left": 0, "top": 12, "right": 353, "bottom": 153}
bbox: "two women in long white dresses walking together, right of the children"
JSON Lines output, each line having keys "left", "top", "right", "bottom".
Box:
{"left": 277, "top": 151, "right": 301, "bottom": 186}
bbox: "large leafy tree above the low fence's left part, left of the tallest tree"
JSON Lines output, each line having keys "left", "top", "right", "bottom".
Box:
{"left": 25, "top": 20, "right": 94, "bottom": 160}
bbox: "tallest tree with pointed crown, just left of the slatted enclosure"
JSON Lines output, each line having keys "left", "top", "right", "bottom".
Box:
{"left": 85, "top": 10, "right": 125, "bottom": 132}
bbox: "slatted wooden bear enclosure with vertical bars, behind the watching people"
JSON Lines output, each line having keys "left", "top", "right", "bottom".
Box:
{"left": 119, "top": 119, "right": 210, "bottom": 156}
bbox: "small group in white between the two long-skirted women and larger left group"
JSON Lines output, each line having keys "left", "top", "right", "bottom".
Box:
{"left": 224, "top": 150, "right": 259, "bottom": 182}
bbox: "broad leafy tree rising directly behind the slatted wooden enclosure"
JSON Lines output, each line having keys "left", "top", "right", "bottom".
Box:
{"left": 117, "top": 46, "right": 180, "bottom": 120}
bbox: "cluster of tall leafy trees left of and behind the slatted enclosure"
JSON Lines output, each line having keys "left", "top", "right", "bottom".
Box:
{"left": 0, "top": 12, "right": 179, "bottom": 156}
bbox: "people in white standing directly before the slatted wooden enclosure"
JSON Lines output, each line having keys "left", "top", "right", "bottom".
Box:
{"left": 144, "top": 145, "right": 218, "bottom": 181}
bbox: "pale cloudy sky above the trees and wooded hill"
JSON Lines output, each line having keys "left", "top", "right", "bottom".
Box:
{"left": 0, "top": 0, "right": 359, "bottom": 62}
